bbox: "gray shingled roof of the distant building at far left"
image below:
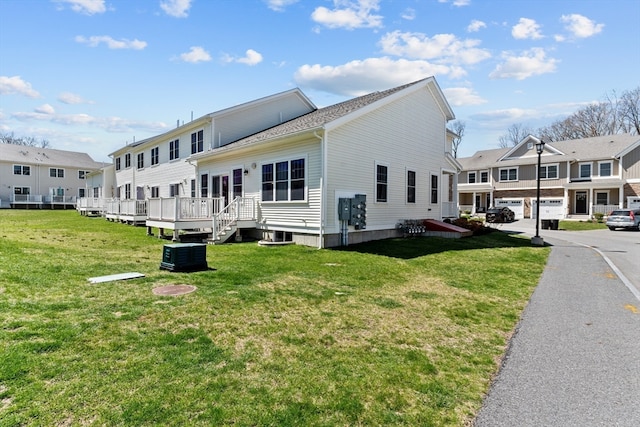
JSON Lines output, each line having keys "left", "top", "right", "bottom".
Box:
{"left": 0, "top": 144, "right": 103, "bottom": 170}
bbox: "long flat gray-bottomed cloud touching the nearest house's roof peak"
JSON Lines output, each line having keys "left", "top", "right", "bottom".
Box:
{"left": 294, "top": 57, "right": 464, "bottom": 96}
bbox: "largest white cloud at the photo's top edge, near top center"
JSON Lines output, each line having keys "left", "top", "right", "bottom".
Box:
{"left": 311, "top": 0, "right": 382, "bottom": 30}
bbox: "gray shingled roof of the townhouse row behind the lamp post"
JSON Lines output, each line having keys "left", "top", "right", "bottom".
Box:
{"left": 457, "top": 134, "right": 640, "bottom": 170}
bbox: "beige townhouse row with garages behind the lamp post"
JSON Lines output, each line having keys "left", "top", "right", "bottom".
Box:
{"left": 458, "top": 134, "right": 640, "bottom": 218}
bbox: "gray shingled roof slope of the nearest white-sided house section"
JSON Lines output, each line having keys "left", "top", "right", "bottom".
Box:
{"left": 200, "top": 79, "right": 425, "bottom": 154}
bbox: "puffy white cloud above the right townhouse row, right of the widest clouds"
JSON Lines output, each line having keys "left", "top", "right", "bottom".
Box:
{"left": 489, "top": 48, "right": 559, "bottom": 80}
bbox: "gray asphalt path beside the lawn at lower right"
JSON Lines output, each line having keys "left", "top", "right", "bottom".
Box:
{"left": 475, "top": 222, "right": 640, "bottom": 427}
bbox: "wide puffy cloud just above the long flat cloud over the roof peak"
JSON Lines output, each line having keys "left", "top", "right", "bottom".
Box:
{"left": 380, "top": 31, "right": 491, "bottom": 64}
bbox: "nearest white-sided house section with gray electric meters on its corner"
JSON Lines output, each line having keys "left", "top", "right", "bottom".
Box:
{"left": 172, "top": 77, "right": 460, "bottom": 247}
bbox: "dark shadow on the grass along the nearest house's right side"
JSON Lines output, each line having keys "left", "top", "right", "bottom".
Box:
{"left": 334, "top": 230, "right": 548, "bottom": 259}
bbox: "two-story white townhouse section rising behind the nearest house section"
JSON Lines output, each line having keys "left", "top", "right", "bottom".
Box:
{"left": 106, "top": 89, "right": 316, "bottom": 222}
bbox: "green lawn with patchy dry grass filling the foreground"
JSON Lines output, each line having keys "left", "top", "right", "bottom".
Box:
{"left": 0, "top": 210, "right": 549, "bottom": 427}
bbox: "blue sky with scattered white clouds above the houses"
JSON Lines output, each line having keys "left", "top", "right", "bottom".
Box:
{"left": 0, "top": 0, "right": 640, "bottom": 161}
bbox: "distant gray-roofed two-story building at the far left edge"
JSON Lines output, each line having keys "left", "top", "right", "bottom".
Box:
{"left": 0, "top": 144, "right": 103, "bottom": 208}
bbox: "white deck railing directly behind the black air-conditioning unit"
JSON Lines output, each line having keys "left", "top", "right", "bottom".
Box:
{"left": 147, "top": 197, "right": 223, "bottom": 222}
